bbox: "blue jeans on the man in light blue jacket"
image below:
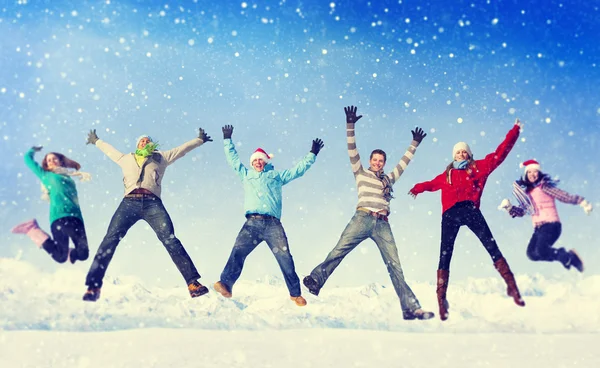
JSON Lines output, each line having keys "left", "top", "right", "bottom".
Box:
{"left": 221, "top": 217, "right": 302, "bottom": 296}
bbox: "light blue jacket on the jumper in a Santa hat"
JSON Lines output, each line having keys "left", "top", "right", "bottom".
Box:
{"left": 224, "top": 139, "right": 317, "bottom": 219}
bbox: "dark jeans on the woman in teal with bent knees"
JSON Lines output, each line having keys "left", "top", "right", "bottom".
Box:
{"left": 42, "top": 217, "right": 90, "bottom": 263}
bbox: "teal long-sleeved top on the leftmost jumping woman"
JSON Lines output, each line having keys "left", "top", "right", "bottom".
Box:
{"left": 25, "top": 149, "right": 83, "bottom": 224}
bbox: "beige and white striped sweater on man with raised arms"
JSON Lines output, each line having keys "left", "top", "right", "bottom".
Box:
{"left": 346, "top": 125, "right": 419, "bottom": 213}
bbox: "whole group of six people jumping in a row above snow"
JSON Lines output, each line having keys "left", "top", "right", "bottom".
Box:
{"left": 12, "top": 106, "right": 592, "bottom": 320}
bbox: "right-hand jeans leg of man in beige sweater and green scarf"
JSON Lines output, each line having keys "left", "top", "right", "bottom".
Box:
{"left": 142, "top": 198, "right": 202, "bottom": 284}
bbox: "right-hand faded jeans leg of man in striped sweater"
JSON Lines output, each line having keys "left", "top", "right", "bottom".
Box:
{"left": 371, "top": 220, "right": 421, "bottom": 316}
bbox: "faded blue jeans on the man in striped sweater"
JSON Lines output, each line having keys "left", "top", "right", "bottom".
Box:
{"left": 310, "top": 211, "right": 421, "bottom": 312}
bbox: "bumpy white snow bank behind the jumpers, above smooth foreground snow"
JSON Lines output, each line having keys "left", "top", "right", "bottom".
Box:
{"left": 0, "top": 258, "right": 600, "bottom": 334}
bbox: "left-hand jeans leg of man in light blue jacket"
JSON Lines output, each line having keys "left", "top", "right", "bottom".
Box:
{"left": 219, "top": 219, "right": 264, "bottom": 294}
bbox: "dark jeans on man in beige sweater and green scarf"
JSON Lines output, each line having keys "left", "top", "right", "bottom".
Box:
{"left": 85, "top": 196, "right": 200, "bottom": 287}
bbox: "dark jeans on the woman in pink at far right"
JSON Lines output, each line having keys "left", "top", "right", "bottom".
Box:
{"left": 527, "top": 222, "right": 570, "bottom": 264}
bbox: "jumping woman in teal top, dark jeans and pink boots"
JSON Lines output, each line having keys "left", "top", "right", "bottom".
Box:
{"left": 12, "top": 146, "right": 90, "bottom": 263}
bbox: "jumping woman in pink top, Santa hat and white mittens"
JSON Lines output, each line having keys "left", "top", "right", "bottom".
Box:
{"left": 500, "top": 160, "right": 592, "bottom": 272}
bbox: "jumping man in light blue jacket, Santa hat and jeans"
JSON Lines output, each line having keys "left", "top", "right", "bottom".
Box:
{"left": 214, "top": 125, "right": 324, "bottom": 307}
